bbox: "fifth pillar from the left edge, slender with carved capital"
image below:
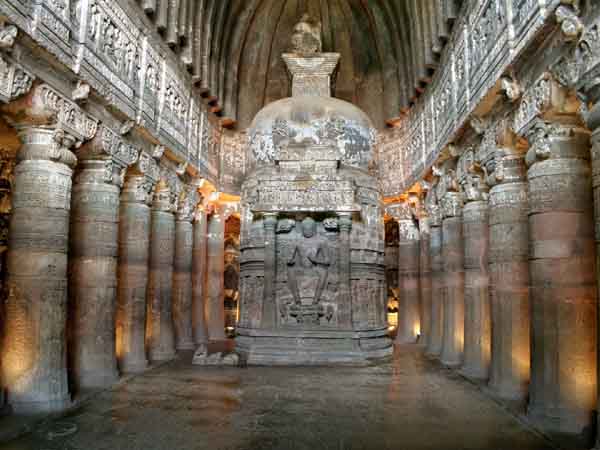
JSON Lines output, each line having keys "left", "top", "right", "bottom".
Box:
{"left": 173, "top": 191, "right": 197, "bottom": 350}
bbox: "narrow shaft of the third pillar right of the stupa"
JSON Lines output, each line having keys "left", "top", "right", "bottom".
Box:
{"left": 426, "top": 224, "right": 444, "bottom": 358}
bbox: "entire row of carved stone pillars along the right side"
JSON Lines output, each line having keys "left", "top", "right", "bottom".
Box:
{"left": 396, "top": 96, "right": 600, "bottom": 433}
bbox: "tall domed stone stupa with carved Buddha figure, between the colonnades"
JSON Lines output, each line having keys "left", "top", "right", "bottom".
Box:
{"left": 236, "top": 16, "right": 392, "bottom": 365}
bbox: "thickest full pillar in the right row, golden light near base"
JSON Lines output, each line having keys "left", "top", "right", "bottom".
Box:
{"left": 527, "top": 122, "right": 597, "bottom": 433}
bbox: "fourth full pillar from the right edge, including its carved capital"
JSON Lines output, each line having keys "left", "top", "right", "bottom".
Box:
{"left": 440, "top": 170, "right": 465, "bottom": 367}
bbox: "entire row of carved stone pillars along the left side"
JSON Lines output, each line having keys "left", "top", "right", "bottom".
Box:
{"left": 0, "top": 87, "right": 230, "bottom": 413}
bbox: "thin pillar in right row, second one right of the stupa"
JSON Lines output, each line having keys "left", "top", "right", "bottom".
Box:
{"left": 419, "top": 210, "right": 432, "bottom": 348}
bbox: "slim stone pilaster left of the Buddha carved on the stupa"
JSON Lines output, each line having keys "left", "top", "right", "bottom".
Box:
{"left": 261, "top": 213, "right": 277, "bottom": 328}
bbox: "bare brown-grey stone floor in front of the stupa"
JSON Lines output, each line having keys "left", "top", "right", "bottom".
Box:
{"left": 0, "top": 347, "right": 576, "bottom": 450}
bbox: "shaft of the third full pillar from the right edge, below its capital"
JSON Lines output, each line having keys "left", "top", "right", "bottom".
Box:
{"left": 461, "top": 200, "right": 491, "bottom": 379}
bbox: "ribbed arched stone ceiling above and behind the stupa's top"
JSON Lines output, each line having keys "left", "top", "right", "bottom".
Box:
{"left": 141, "top": 0, "right": 460, "bottom": 129}
